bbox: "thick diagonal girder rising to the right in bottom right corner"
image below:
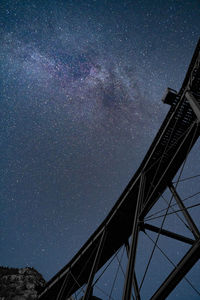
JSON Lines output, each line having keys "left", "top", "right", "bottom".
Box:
{"left": 151, "top": 239, "right": 200, "bottom": 300}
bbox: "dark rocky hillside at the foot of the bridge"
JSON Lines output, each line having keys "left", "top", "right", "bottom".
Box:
{"left": 0, "top": 267, "right": 45, "bottom": 300}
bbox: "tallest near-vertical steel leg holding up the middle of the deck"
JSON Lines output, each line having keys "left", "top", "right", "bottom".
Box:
{"left": 122, "top": 174, "right": 144, "bottom": 300}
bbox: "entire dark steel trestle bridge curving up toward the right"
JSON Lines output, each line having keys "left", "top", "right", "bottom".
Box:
{"left": 39, "top": 40, "right": 200, "bottom": 300}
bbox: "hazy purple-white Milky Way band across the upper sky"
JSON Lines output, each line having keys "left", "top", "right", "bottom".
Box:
{"left": 3, "top": 26, "right": 159, "bottom": 138}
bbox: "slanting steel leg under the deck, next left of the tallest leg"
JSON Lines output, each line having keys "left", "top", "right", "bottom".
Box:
{"left": 83, "top": 229, "right": 106, "bottom": 300}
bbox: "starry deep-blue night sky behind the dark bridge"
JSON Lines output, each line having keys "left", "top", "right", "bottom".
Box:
{"left": 0, "top": 0, "right": 200, "bottom": 299}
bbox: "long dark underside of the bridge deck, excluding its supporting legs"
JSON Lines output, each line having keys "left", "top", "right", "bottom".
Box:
{"left": 39, "top": 41, "right": 200, "bottom": 300}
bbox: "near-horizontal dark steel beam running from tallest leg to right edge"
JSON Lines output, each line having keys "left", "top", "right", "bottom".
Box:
{"left": 142, "top": 223, "right": 195, "bottom": 245}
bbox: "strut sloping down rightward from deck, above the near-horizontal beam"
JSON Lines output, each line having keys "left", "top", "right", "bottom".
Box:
{"left": 168, "top": 183, "right": 200, "bottom": 239}
